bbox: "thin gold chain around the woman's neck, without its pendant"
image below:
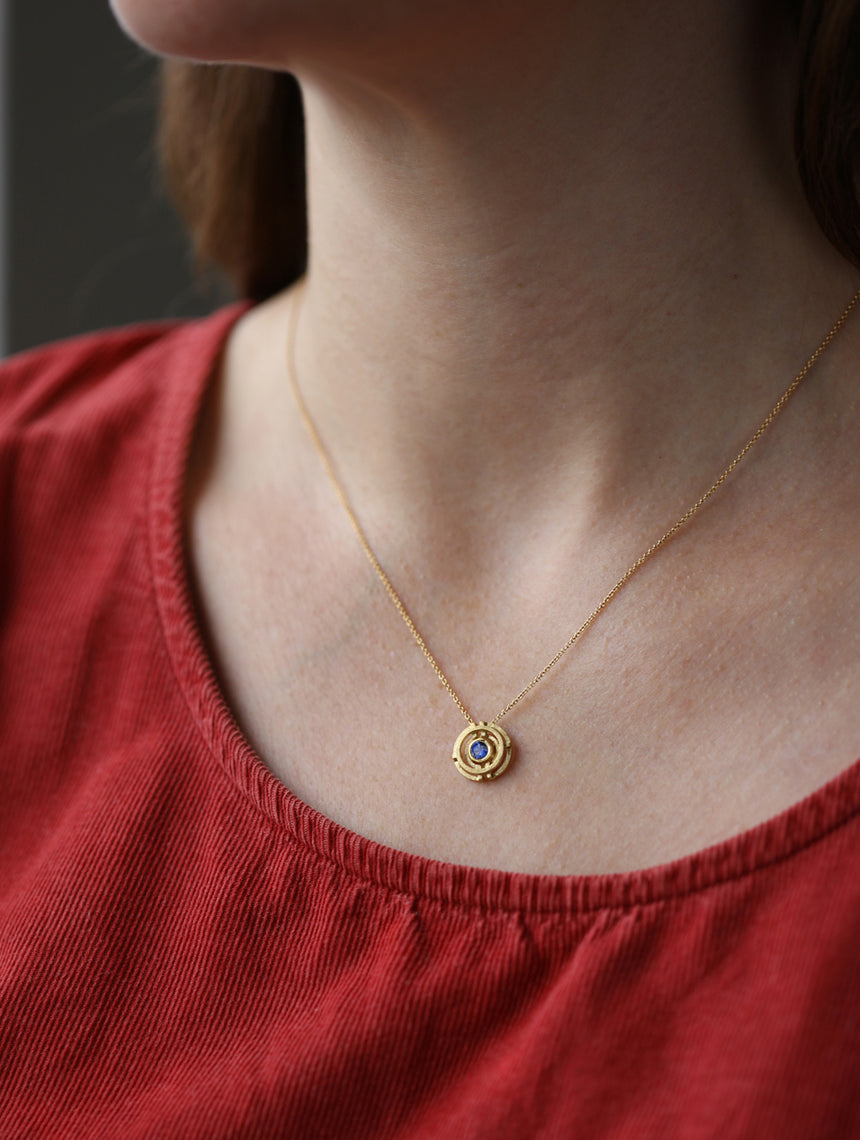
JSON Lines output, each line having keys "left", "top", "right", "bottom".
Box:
{"left": 287, "top": 282, "right": 860, "bottom": 724}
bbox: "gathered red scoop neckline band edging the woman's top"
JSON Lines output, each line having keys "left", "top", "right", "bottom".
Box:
{"left": 148, "top": 302, "right": 860, "bottom": 915}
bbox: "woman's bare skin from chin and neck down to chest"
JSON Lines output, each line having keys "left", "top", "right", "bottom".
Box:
{"left": 114, "top": 0, "right": 860, "bottom": 873}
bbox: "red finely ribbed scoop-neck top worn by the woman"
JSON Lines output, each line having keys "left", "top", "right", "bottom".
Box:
{"left": 0, "top": 308, "right": 860, "bottom": 1140}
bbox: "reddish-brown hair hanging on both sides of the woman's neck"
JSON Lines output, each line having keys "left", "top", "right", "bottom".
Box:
{"left": 160, "top": 0, "right": 860, "bottom": 300}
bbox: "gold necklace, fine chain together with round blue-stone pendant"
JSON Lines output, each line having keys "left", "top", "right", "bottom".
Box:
{"left": 287, "top": 283, "right": 860, "bottom": 782}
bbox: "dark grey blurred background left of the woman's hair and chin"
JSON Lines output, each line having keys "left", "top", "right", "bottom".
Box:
{"left": 0, "top": 0, "right": 224, "bottom": 353}
